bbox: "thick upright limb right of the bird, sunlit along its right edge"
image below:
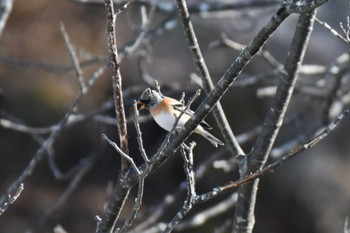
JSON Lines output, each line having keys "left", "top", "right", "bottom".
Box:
{"left": 232, "top": 9, "right": 315, "bottom": 233}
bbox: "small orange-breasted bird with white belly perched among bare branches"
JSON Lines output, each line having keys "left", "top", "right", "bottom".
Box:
{"left": 137, "top": 88, "right": 224, "bottom": 147}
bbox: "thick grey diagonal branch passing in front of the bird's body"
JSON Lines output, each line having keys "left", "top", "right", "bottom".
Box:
{"left": 97, "top": 0, "right": 327, "bottom": 233}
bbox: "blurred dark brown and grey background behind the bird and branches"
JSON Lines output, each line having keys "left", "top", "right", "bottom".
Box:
{"left": 0, "top": 0, "right": 350, "bottom": 233}
